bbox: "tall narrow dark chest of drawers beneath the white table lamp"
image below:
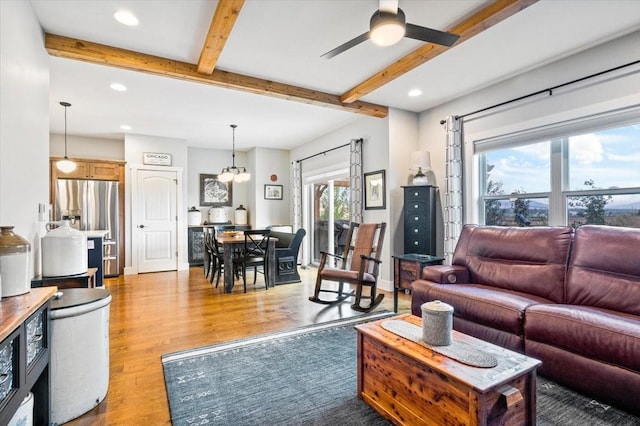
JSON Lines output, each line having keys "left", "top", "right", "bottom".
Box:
{"left": 403, "top": 185, "right": 436, "bottom": 256}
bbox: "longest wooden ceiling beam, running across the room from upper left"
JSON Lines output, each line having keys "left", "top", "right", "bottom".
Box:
{"left": 45, "top": 34, "right": 389, "bottom": 118}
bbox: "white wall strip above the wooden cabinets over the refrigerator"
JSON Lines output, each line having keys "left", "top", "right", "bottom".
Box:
{"left": 49, "top": 133, "right": 124, "bottom": 161}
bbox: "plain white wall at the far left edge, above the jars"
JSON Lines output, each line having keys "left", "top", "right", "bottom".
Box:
{"left": 0, "top": 1, "right": 49, "bottom": 275}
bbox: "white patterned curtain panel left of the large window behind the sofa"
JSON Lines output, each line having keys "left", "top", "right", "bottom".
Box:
{"left": 444, "top": 116, "right": 464, "bottom": 265}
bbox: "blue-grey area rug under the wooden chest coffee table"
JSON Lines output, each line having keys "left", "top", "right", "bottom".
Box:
{"left": 162, "top": 313, "right": 640, "bottom": 426}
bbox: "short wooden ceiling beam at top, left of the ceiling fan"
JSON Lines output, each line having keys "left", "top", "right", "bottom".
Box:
{"left": 198, "top": 0, "right": 244, "bottom": 74}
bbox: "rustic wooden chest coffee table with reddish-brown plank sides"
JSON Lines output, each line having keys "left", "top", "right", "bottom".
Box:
{"left": 356, "top": 314, "right": 541, "bottom": 425}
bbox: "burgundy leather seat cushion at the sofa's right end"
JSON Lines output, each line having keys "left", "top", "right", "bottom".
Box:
{"left": 524, "top": 305, "right": 640, "bottom": 372}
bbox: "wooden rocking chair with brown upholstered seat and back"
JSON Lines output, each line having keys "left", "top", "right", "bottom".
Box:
{"left": 309, "top": 222, "right": 387, "bottom": 312}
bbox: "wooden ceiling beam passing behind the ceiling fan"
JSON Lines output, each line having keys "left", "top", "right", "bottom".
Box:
{"left": 340, "top": 0, "right": 538, "bottom": 103}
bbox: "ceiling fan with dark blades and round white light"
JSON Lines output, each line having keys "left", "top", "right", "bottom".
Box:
{"left": 321, "top": 0, "right": 460, "bottom": 59}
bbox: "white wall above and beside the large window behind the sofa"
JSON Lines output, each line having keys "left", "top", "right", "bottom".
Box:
{"left": 419, "top": 32, "right": 640, "bottom": 226}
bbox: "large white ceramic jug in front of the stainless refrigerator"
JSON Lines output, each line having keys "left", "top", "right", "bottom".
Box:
{"left": 41, "top": 220, "right": 88, "bottom": 277}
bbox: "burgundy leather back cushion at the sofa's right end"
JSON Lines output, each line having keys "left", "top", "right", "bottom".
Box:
{"left": 566, "top": 225, "right": 640, "bottom": 315}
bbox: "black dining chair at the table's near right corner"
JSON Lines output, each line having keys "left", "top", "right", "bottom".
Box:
{"left": 233, "top": 229, "right": 271, "bottom": 293}
